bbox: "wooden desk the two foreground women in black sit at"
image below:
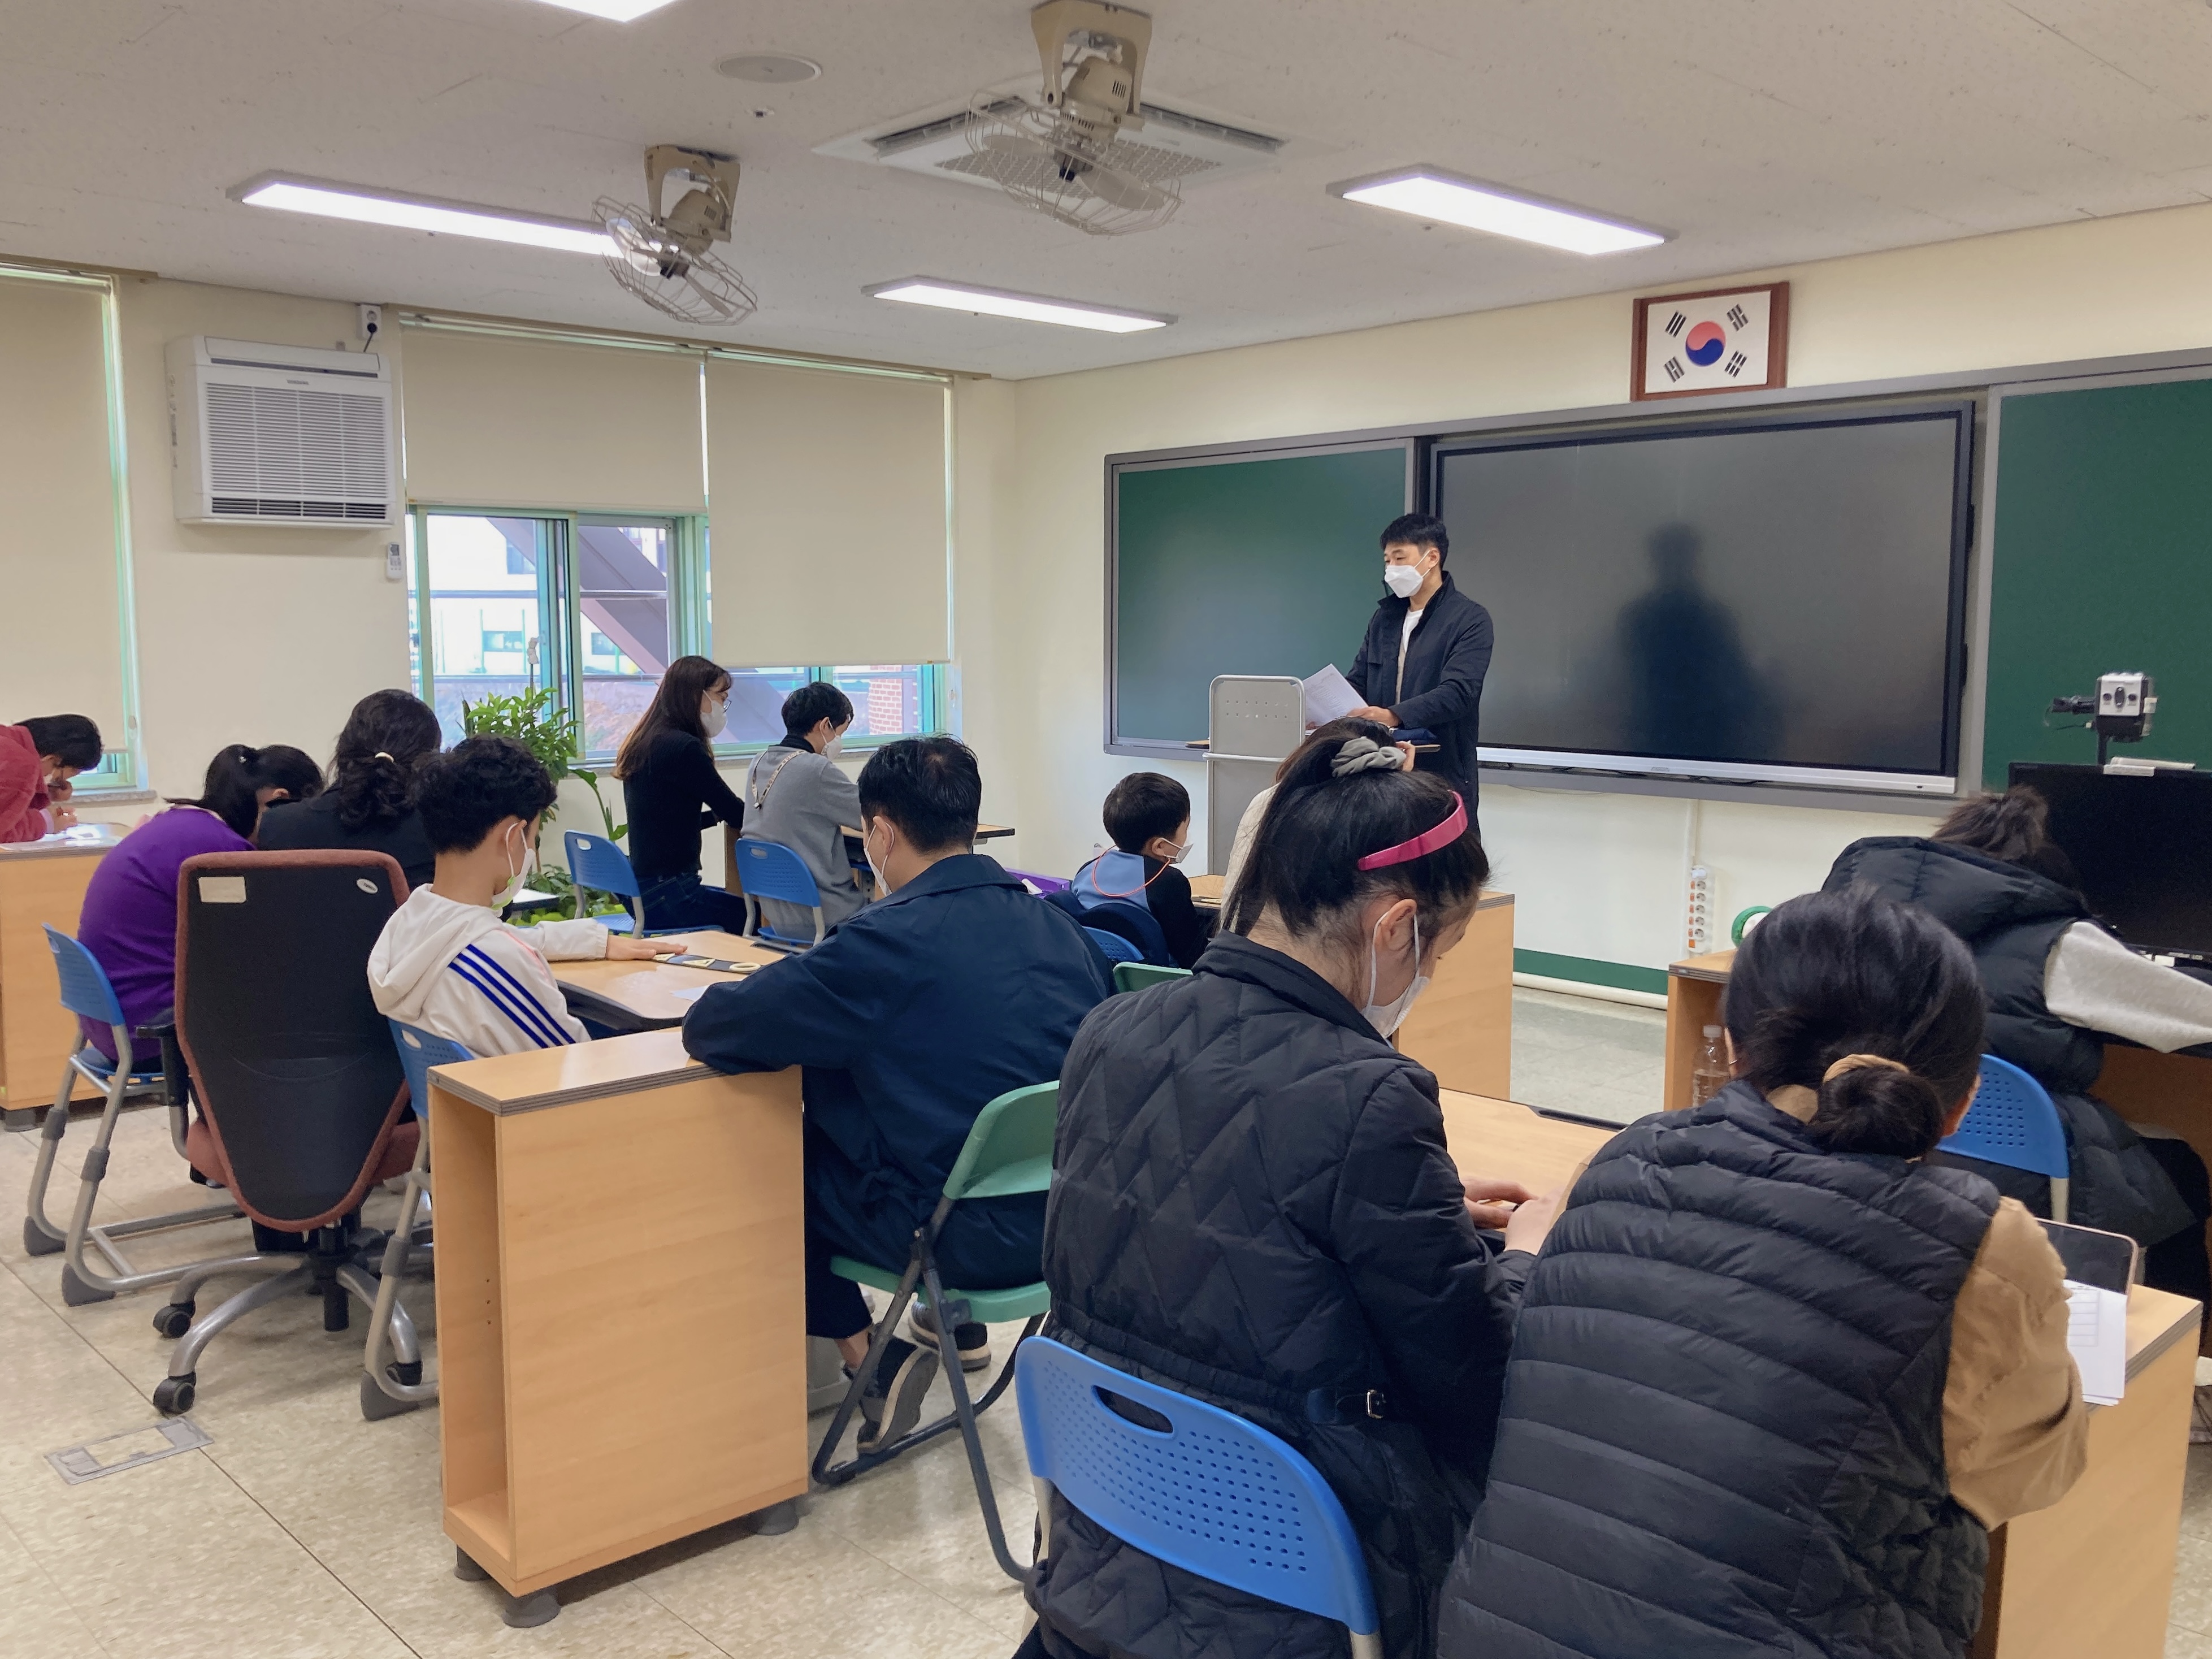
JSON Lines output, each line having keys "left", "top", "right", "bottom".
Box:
{"left": 1442, "top": 1090, "right": 2197, "bottom": 1659}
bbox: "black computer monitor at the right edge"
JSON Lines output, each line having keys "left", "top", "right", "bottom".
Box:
{"left": 2011, "top": 761, "right": 2212, "bottom": 956}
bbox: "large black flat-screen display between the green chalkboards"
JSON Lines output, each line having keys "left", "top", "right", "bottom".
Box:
{"left": 1431, "top": 402, "right": 1973, "bottom": 794}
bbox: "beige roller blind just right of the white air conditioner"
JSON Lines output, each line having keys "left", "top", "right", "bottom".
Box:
{"left": 400, "top": 327, "right": 706, "bottom": 513}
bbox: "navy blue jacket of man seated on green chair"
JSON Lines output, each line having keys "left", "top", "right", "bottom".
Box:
{"left": 683, "top": 854, "right": 1113, "bottom": 1216}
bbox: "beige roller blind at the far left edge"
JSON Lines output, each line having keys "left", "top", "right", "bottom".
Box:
{"left": 0, "top": 276, "right": 125, "bottom": 750}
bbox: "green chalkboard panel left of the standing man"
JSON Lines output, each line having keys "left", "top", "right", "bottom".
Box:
{"left": 1108, "top": 443, "right": 1407, "bottom": 743}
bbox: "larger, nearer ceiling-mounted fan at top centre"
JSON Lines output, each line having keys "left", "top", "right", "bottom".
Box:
{"left": 966, "top": 0, "right": 1183, "bottom": 237}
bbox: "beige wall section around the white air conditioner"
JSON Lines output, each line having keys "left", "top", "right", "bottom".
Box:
{"left": 117, "top": 279, "right": 407, "bottom": 794}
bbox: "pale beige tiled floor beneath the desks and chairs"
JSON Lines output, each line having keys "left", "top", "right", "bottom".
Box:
{"left": 0, "top": 991, "right": 2212, "bottom": 1659}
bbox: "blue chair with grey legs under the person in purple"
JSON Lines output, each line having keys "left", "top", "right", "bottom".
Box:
{"left": 22, "top": 927, "right": 241, "bottom": 1307}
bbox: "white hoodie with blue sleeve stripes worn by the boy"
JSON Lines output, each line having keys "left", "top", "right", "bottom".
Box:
{"left": 370, "top": 887, "right": 606, "bottom": 1055}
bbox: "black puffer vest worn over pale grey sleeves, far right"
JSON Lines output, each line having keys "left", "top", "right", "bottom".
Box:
{"left": 1823, "top": 836, "right": 2197, "bottom": 1245}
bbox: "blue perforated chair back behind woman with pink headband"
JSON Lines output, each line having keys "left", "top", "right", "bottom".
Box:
{"left": 1013, "top": 1336, "right": 1382, "bottom": 1659}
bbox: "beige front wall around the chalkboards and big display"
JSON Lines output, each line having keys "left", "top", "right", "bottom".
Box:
{"left": 973, "top": 206, "right": 2212, "bottom": 967}
